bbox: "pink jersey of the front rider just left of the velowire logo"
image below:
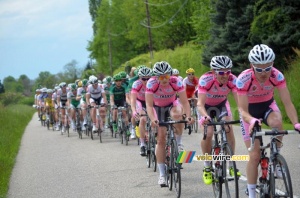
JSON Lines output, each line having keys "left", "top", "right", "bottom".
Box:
{"left": 146, "top": 76, "right": 185, "bottom": 107}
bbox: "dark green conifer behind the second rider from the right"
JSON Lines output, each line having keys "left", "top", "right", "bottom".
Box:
{"left": 202, "top": 0, "right": 255, "bottom": 73}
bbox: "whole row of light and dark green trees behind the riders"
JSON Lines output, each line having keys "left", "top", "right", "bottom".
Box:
{"left": 88, "top": 0, "right": 300, "bottom": 73}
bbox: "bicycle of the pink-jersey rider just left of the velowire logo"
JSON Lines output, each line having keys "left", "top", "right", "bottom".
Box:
{"left": 159, "top": 118, "right": 187, "bottom": 198}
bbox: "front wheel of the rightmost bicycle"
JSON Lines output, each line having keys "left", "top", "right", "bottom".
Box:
{"left": 270, "top": 154, "right": 293, "bottom": 197}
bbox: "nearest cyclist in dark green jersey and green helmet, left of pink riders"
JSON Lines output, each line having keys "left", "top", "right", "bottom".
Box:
{"left": 109, "top": 74, "right": 130, "bottom": 135}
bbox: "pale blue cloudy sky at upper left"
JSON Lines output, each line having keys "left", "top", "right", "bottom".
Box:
{"left": 0, "top": 0, "right": 93, "bottom": 82}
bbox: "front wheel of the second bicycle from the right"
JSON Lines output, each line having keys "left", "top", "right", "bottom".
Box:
{"left": 222, "top": 144, "right": 239, "bottom": 197}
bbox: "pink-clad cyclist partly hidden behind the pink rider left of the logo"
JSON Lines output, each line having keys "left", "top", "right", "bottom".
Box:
{"left": 131, "top": 67, "right": 152, "bottom": 156}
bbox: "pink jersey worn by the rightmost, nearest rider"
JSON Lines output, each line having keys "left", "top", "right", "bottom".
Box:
{"left": 236, "top": 67, "right": 286, "bottom": 103}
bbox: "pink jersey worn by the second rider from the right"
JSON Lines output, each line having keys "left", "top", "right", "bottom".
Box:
{"left": 198, "top": 72, "right": 237, "bottom": 106}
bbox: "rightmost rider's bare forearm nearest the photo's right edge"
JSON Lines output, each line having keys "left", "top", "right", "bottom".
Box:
{"left": 278, "top": 87, "right": 298, "bottom": 125}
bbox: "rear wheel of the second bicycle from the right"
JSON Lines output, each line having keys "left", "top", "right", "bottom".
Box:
{"left": 211, "top": 147, "right": 223, "bottom": 198}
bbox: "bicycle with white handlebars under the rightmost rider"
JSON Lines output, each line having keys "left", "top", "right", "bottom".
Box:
{"left": 246, "top": 123, "right": 300, "bottom": 197}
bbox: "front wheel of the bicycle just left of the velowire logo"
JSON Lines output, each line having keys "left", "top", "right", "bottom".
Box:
{"left": 171, "top": 140, "right": 181, "bottom": 198}
